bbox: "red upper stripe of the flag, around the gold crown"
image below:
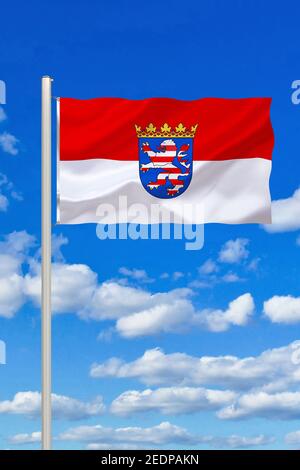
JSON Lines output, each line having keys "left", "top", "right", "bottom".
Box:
{"left": 60, "top": 98, "right": 274, "bottom": 161}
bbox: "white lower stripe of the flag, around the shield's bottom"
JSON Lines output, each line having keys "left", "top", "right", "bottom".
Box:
{"left": 59, "top": 158, "right": 272, "bottom": 224}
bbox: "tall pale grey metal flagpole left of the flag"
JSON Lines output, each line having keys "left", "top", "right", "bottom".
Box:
{"left": 41, "top": 76, "right": 52, "bottom": 450}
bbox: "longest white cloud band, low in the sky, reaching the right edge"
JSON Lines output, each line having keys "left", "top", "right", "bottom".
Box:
{"left": 90, "top": 341, "right": 300, "bottom": 391}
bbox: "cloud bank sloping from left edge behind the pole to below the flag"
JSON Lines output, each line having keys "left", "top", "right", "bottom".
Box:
{"left": 0, "top": 232, "right": 254, "bottom": 338}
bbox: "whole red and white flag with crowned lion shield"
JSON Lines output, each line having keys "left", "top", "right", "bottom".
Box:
{"left": 57, "top": 98, "right": 274, "bottom": 224}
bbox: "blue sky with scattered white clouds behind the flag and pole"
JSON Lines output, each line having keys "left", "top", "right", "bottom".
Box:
{"left": 0, "top": 0, "right": 300, "bottom": 449}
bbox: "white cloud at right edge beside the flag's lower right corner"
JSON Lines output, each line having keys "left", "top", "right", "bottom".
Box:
{"left": 263, "top": 188, "right": 300, "bottom": 233}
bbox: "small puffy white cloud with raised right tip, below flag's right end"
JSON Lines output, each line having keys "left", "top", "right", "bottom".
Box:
{"left": 195, "top": 293, "right": 255, "bottom": 332}
